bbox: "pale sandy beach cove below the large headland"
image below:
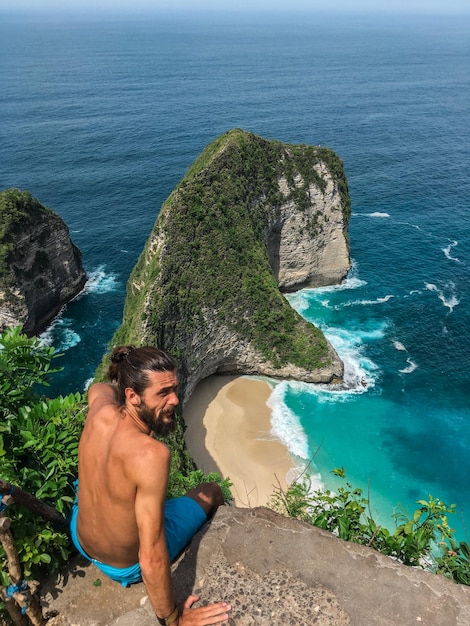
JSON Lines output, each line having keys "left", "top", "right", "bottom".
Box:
{"left": 183, "top": 376, "right": 294, "bottom": 507}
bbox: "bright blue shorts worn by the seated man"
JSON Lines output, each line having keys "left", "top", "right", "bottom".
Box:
{"left": 70, "top": 496, "right": 207, "bottom": 587}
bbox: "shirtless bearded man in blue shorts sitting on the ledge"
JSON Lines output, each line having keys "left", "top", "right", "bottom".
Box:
{"left": 71, "top": 346, "right": 231, "bottom": 626}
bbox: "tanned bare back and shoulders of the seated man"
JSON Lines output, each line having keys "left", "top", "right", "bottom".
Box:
{"left": 77, "top": 383, "right": 168, "bottom": 567}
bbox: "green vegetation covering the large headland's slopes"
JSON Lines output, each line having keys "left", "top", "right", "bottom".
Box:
{"left": 113, "top": 130, "right": 350, "bottom": 373}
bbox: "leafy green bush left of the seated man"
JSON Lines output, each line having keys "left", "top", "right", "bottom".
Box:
{"left": 0, "top": 327, "right": 84, "bottom": 585}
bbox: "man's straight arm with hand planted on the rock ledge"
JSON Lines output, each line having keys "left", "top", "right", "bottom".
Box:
{"left": 135, "top": 440, "right": 231, "bottom": 626}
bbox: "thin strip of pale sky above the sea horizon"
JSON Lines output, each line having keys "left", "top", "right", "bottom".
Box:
{"left": 0, "top": 0, "right": 470, "bottom": 14}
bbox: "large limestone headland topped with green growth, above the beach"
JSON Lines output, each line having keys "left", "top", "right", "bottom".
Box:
{"left": 113, "top": 130, "right": 350, "bottom": 400}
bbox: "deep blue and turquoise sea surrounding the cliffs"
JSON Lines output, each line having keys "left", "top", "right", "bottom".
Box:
{"left": 0, "top": 8, "right": 470, "bottom": 540}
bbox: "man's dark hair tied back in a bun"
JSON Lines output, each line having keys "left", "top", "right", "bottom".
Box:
{"left": 106, "top": 346, "right": 176, "bottom": 406}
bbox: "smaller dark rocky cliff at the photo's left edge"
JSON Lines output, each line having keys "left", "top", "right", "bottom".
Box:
{"left": 0, "top": 189, "right": 86, "bottom": 335}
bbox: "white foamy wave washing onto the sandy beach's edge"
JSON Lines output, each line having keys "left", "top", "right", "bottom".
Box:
{"left": 267, "top": 381, "right": 311, "bottom": 461}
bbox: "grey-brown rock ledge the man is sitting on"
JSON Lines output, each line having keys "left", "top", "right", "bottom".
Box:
{"left": 42, "top": 506, "right": 470, "bottom": 626}
